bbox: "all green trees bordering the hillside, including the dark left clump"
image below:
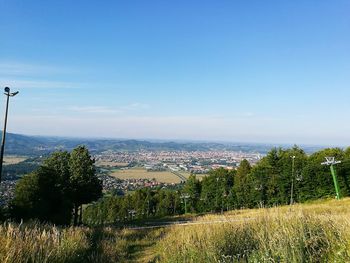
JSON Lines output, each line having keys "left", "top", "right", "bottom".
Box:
{"left": 0, "top": 146, "right": 350, "bottom": 225}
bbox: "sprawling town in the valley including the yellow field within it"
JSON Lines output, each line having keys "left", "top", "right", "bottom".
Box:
{"left": 0, "top": 147, "right": 264, "bottom": 205}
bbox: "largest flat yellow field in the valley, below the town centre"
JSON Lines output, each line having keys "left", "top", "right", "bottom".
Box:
{"left": 110, "top": 168, "right": 181, "bottom": 183}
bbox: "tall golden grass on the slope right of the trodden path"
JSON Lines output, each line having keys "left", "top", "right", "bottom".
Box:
{"left": 158, "top": 198, "right": 350, "bottom": 262}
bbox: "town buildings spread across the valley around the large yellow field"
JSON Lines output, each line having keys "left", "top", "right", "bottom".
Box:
{"left": 0, "top": 150, "right": 260, "bottom": 206}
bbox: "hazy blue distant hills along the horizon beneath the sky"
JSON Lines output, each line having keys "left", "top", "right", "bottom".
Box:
{"left": 5, "top": 133, "right": 324, "bottom": 155}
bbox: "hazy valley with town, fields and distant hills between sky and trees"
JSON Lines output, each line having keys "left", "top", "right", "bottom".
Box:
{"left": 0, "top": 133, "right": 344, "bottom": 210}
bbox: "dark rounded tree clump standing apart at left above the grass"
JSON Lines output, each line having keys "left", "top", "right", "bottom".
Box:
{"left": 11, "top": 146, "right": 102, "bottom": 224}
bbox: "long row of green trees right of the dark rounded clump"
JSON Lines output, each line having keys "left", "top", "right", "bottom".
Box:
{"left": 83, "top": 146, "right": 350, "bottom": 224}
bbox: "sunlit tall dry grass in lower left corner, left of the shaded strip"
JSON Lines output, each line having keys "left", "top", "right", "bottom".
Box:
{"left": 0, "top": 224, "right": 89, "bottom": 263}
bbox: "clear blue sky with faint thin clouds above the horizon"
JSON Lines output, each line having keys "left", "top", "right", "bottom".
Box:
{"left": 0, "top": 0, "right": 350, "bottom": 145}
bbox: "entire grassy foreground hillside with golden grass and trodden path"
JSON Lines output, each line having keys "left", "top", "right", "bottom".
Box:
{"left": 0, "top": 198, "right": 350, "bottom": 262}
